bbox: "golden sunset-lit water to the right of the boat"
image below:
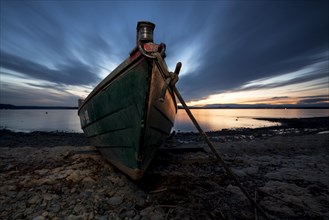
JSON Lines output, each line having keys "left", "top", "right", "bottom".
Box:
{"left": 174, "top": 109, "right": 329, "bottom": 131}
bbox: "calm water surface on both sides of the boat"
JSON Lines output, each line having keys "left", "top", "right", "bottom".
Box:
{"left": 0, "top": 109, "right": 329, "bottom": 132}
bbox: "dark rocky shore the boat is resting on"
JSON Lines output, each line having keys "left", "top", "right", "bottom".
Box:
{"left": 0, "top": 118, "right": 329, "bottom": 220}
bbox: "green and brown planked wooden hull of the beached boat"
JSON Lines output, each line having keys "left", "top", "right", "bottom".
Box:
{"left": 79, "top": 54, "right": 177, "bottom": 179}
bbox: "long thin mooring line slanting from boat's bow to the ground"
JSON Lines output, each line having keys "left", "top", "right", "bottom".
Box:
{"left": 172, "top": 62, "right": 270, "bottom": 219}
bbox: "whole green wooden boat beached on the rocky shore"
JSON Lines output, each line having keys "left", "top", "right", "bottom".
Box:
{"left": 78, "top": 21, "right": 179, "bottom": 180}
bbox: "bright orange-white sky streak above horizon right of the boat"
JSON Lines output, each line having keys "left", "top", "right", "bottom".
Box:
{"left": 189, "top": 58, "right": 329, "bottom": 107}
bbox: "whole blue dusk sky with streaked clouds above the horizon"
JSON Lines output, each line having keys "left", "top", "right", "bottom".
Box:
{"left": 0, "top": 0, "right": 329, "bottom": 107}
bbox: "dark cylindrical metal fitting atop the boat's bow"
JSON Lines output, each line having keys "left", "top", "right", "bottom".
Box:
{"left": 136, "top": 21, "right": 155, "bottom": 45}
